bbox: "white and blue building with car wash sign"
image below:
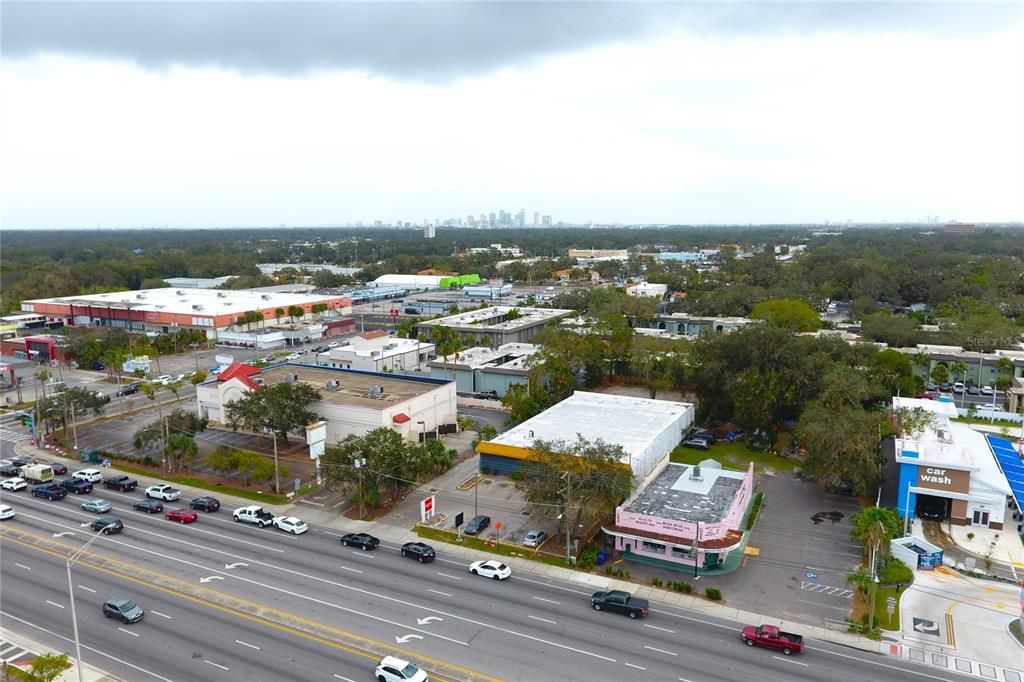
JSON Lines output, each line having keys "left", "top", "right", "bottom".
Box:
{"left": 890, "top": 397, "right": 1022, "bottom": 530}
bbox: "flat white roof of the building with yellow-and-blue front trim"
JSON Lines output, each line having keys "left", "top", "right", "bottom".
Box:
{"left": 489, "top": 391, "right": 693, "bottom": 455}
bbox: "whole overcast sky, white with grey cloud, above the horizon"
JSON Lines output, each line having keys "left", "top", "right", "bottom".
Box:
{"left": 0, "top": 0, "right": 1024, "bottom": 228}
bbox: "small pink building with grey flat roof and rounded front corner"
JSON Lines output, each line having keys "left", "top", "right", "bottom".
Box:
{"left": 604, "top": 459, "right": 754, "bottom": 569}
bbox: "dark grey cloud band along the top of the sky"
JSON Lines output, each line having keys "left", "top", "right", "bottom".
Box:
{"left": 0, "top": 1, "right": 1022, "bottom": 80}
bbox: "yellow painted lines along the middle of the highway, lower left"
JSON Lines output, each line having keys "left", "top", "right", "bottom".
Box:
{"left": 3, "top": 531, "right": 503, "bottom": 682}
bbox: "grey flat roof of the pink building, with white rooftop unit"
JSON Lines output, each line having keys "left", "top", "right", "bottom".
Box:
{"left": 623, "top": 460, "right": 746, "bottom": 523}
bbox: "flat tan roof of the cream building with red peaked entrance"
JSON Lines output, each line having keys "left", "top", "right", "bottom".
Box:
{"left": 259, "top": 363, "right": 453, "bottom": 410}
